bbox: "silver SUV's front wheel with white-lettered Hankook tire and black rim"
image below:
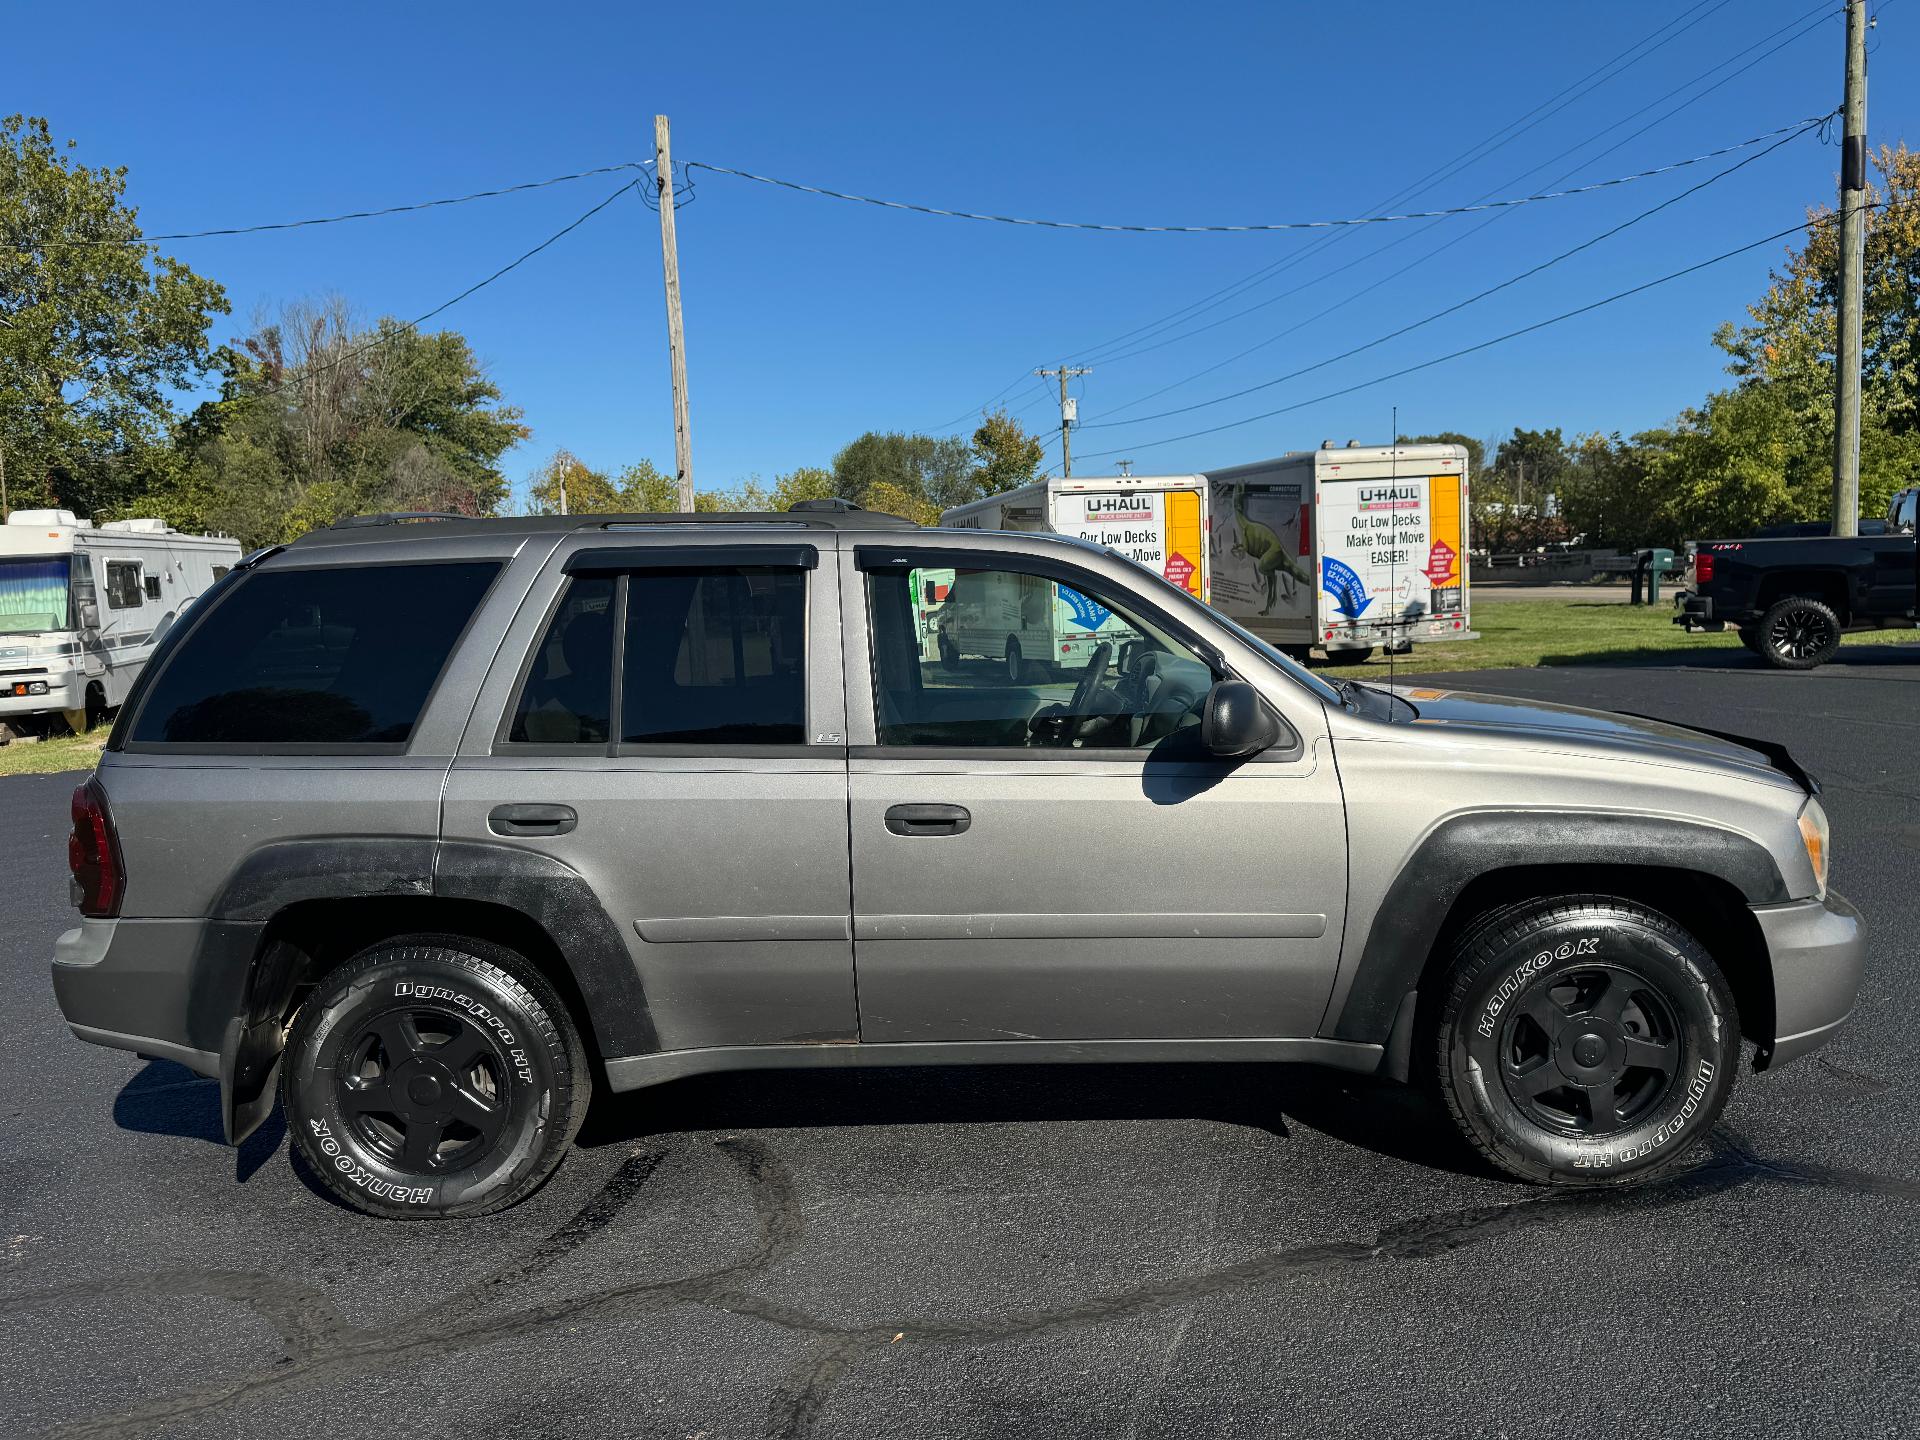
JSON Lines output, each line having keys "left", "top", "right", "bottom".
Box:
{"left": 1434, "top": 895, "right": 1740, "bottom": 1185}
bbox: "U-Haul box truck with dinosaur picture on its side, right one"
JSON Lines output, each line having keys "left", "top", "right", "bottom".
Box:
{"left": 1206, "top": 445, "right": 1476, "bottom": 659}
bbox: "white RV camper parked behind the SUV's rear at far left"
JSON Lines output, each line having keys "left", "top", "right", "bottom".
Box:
{"left": 0, "top": 511, "right": 240, "bottom": 739}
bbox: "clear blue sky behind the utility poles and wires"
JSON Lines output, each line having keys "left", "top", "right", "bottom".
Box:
{"left": 0, "top": 0, "right": 1920, "bottom": 506}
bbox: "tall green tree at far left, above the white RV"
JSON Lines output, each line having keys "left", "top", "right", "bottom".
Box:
{"left": 0, "top": 115, "right": 227, "bottom": 515}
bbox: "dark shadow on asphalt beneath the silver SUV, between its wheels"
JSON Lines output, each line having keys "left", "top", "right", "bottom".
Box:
{"left": 580, "top": 1064, "right": 1500, "bottom": 1179}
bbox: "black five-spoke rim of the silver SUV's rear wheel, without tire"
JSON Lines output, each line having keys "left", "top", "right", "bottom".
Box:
{"left": 334, "top": 1008, "right": 511, "bottom": 1175}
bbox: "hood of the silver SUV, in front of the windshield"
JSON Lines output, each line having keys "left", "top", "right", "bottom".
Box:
{"left": 1394, "top": 685, "right": 1816, "bottom": 793}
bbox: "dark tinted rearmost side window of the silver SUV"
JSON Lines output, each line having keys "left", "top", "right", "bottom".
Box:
{"left": 131, "top": 561, "right": 499, "bottom": 745}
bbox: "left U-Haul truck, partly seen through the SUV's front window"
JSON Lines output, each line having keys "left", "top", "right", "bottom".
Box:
{"left": 936, "top": 474, "right": 1206, "bottom": 680}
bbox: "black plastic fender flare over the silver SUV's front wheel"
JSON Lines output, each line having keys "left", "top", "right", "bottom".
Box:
{"left": 1321, "top": 810, "right": 1791, "bottom": 1044}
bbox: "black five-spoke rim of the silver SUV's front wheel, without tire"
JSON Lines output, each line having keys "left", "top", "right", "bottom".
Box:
{"left": 1500, "top": 966, "right": 1682, "bottom": 1137}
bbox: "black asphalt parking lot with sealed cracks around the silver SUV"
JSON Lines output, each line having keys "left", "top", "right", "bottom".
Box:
{"left": 0, "top": 645, "right": 1920, "bottom": 1440}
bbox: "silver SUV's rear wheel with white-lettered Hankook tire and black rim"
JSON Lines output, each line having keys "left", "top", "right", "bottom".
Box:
{"left": 280, "top": 935, "right": 591, "bottom": 1219}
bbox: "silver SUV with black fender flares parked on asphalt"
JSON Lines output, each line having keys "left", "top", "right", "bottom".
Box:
{"left": 54, "top": 501, "right": 1862, "bottom": 1217}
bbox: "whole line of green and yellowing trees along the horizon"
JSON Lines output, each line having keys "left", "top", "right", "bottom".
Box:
{"left": 0, "top": 115, "right": 1920, "bottom": 551}
